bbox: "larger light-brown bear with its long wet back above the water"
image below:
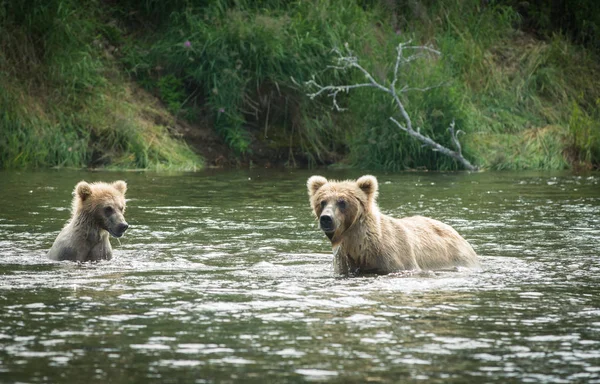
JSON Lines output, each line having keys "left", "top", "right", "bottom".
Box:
{"left": 307, "top": 175, "right": 479, "bottom": 274}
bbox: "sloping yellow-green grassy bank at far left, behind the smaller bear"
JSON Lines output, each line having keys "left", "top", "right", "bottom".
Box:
{"left": 0, "top": 0, "right": 202, "bottom": 169}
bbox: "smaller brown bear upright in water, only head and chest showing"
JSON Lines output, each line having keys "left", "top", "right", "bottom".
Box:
{"left": 48, "top": 180, "right": 129, "bottom": 261}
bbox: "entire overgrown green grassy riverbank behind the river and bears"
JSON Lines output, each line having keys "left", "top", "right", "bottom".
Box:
{"left": 0, "top": 0, "right": 600, "bottom": 170}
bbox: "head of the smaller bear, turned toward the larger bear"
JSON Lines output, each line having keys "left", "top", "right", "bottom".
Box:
{"left": 73, "top": 180, "right": 129, "bottom": 237}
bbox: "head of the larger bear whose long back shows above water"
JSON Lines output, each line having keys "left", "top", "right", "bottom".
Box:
{"left": 306, "top": 175, "right": 378, "bottom": 245}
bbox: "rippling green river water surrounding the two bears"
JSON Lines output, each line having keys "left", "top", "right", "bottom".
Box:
{"left": 0, "top": 170, "right": 600, "bottom": 384}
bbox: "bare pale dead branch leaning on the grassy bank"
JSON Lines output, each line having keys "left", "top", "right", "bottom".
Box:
{"left": 306, "top": 41, "right": 478, "bottom": 171}
